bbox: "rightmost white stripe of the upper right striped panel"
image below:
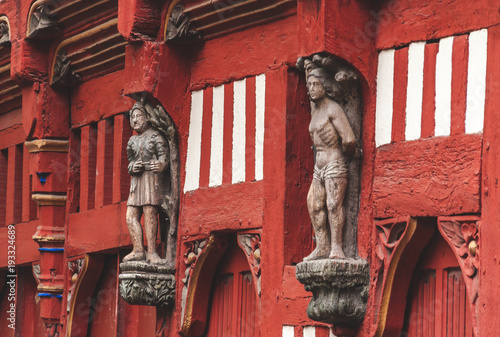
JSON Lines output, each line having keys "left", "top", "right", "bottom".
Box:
{"left": 465, "top": 29, "right": 488, "bottom": 133}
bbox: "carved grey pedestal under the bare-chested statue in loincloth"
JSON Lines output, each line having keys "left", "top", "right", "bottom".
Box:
{"left": 296, "top": 259, "right": 370, "bottom": 328}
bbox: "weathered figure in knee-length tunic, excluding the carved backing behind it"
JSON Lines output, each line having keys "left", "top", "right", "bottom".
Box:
{"left": 123, "top": 102, "right": 169, "bottom": 264}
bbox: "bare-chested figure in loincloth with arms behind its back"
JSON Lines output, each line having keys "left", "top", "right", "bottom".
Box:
{"left": 304, "top": 68, "right": 356, "bottom": 261}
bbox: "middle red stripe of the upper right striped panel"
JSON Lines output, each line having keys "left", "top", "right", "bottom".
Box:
{"left": 421, "top": 43, "right": 439, "bottom": 138}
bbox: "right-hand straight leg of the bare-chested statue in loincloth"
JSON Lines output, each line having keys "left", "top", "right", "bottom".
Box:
{"left": 325, "top": 178, "right": 347, "bottom": 259}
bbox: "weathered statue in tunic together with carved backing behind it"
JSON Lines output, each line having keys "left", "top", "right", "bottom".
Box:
{"left": 123, "top": 99, "right": 178, "bottom": 265}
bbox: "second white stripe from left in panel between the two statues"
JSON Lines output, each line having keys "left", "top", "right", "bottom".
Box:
{"left": 208, "top": 85, "right": 224, "bottom": 187}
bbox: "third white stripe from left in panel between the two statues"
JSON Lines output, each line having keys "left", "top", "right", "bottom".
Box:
{"left": 232, "top": 79, "right": 246, "bottom": 184}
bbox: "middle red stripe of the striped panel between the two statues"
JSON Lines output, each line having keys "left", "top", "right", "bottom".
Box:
{"left": 222, "top": 82, "right": 234, "bottom": 184}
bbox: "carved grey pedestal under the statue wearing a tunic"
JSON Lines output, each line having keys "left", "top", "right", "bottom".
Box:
{"left": 119, "top": 262, "right": 175, "bottom": 307}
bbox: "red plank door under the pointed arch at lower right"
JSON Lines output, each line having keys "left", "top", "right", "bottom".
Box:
{"left": 401, "top": 233, "right": 473, "bottom": 337}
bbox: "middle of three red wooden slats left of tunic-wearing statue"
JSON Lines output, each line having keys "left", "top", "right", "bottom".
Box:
{"left": 95, "top": 119, "right": 114, "bottom": 207}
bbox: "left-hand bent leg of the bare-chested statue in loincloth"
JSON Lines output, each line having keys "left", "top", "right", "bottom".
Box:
{"left": 304, "top": 179, "right": 330, "bottom": 261}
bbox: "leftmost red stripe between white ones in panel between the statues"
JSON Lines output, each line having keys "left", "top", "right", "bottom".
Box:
{"left": 200, "top": 87, "right": 213, "bottom": 187}
